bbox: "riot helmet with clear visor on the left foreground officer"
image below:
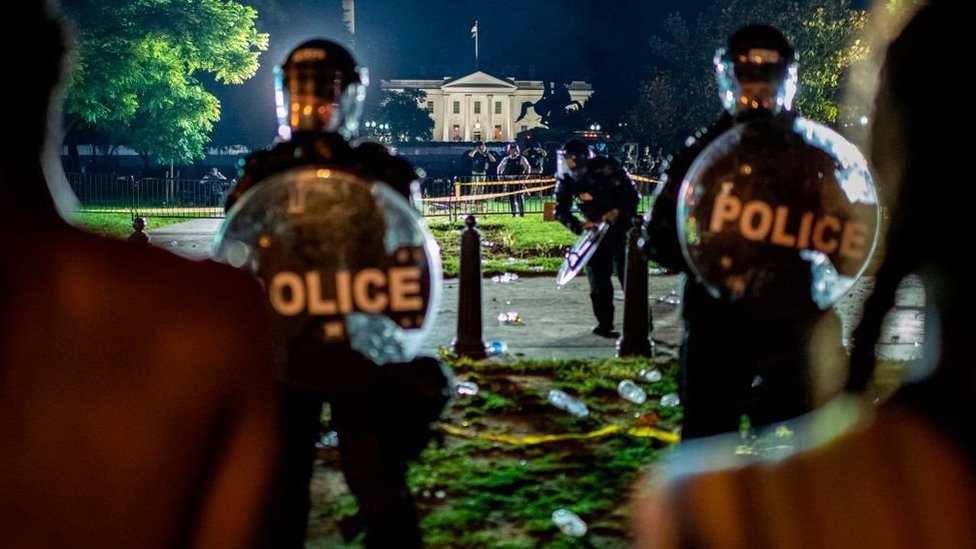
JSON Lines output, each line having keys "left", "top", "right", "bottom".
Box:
{"left": 275, "top": 39, "right": 368, "bottom": 139}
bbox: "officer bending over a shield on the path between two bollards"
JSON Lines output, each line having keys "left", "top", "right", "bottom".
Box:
{"left": 556, "top": 139, "right": 640, "bottom": 338}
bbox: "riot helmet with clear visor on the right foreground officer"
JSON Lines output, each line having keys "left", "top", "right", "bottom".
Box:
{"left": 714, "top": 25, "right": 797, "bottom": 115}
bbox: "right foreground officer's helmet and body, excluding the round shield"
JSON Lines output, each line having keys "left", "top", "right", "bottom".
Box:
{"left": 645, "top": 25, "right": 840, "bottom": 439}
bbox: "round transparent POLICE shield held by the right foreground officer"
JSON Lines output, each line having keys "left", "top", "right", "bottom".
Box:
{"left": 677, "top": 117, "right": 879, "bottom": 315}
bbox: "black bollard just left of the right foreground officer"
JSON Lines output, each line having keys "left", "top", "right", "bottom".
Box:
{"left": 617, "top": 216, "right": 652, "bottom": 357}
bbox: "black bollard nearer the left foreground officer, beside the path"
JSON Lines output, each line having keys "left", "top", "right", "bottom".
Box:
{"left": 454, "top": 215, "right": 488, "bottom": 360}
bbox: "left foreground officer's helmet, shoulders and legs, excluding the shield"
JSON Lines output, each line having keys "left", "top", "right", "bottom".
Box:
{"left": 226, "top": 39, "right": 448, "bottom": 548}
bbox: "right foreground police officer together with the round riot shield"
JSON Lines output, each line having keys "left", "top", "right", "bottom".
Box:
{"left": 646, "top": 25, "right": 878, "bottom": 439}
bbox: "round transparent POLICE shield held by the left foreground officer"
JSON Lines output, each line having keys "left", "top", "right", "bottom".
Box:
{"left": 215, "top": 166, "right": 441, "bottom": 387}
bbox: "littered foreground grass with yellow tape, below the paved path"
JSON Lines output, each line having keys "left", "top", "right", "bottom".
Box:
{"left": 307, "top": 359, "right": 904, "bottom": 549}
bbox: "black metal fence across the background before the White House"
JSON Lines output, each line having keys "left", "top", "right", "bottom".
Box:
{"left": 67, "top": 173, "right": 657, "bottom": 218}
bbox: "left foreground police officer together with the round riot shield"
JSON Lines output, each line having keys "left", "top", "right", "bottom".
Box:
{"left": 217, "top": 40, "right": 448, "bottom": 547}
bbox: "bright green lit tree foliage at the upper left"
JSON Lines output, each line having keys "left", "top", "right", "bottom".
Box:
{"left": 62, "top": 0, "right": 268, "bottom": 164}
